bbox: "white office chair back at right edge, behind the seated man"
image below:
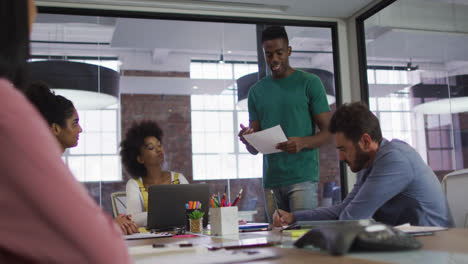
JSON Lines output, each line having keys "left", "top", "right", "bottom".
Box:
{"left": 441, "top": 169, "right": 468, "bottom": 227}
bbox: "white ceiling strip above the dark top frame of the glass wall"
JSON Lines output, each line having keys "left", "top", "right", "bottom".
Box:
{"left": 36, "top": 0, "right": 374, "bottom": 18}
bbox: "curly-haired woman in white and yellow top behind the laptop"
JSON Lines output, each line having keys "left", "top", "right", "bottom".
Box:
{"left": 120, "top": 121, "right": 188, "bottom": 227}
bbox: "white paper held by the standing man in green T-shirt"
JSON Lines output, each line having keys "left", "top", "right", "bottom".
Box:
{"left": 244, "top": 125, "right": 288, "bottom": 154}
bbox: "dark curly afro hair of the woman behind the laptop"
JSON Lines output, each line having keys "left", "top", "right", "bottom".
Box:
{"left": 120, "top": 120, "right": 163, "bottom": 178}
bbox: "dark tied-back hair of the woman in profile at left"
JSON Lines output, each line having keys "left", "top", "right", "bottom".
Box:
{"left": 26, "top": 81, "right": 75, "bottom": 127}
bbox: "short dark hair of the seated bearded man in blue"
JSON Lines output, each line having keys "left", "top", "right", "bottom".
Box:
{"left": 328, "top": 102, "right": 382, "bottom": 144}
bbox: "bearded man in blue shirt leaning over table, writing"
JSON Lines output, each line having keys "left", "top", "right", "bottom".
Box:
{"left": 273, "top": 102, "right": 452, "bottom": 227}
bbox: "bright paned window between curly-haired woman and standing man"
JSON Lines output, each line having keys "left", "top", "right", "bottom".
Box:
{"left": 191, "top": 90, "right": 262, "bottom": 180}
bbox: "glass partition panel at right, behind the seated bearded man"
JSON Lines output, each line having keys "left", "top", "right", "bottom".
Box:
{"left": 363, "top": 0, "right": 468, "bottom": 179}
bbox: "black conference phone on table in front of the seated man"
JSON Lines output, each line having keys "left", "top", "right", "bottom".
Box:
{"left": 294, "top": 224, "right": 422, "bottom": 255}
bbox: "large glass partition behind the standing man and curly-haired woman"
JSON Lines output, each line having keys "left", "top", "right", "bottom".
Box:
{"left": 32, "top": 13, "right": 340, "bottom": 221}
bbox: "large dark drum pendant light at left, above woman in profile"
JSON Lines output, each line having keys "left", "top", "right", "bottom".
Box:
{"left": 29, "top": 60, "right": 120, "bottom": 110}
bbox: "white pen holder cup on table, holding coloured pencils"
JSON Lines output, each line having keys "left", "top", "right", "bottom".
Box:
{"left": 209, "top": 206, "right": 239, "bottom": 236}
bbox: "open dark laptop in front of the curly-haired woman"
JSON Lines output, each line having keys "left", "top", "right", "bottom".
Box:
{"left": 147, "top": 184, "right": 210, "bottom": 231}
